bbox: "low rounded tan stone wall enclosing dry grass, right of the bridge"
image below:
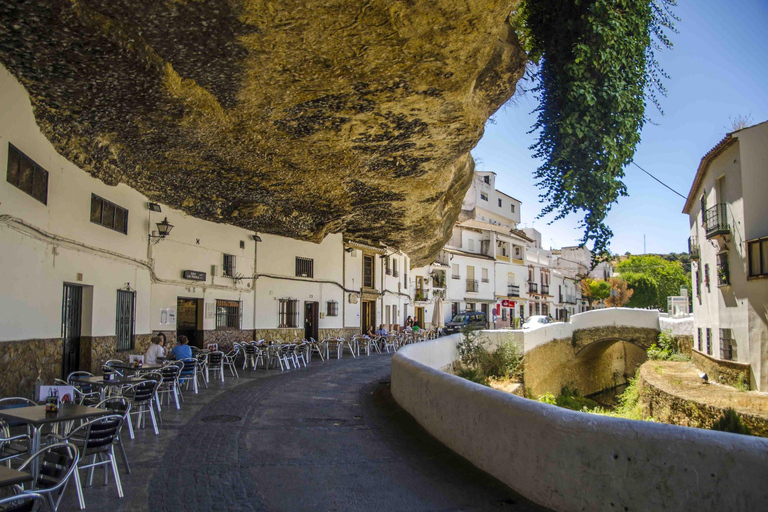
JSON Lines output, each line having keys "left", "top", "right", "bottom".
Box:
{"left": 639, "top": 361, "right": 768, "bottom": 437}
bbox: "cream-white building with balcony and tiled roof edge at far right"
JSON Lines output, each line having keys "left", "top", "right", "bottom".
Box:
{"left": 683, "top": 122, "right": 768, "bottom": 390}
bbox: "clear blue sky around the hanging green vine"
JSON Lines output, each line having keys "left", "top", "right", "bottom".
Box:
{"left": 472, "top": 0, "right": 768, "bottom": 254}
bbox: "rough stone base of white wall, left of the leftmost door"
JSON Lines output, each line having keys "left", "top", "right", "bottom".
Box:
{"left": 0, "top": 338, "right": 63, "bottom": 398}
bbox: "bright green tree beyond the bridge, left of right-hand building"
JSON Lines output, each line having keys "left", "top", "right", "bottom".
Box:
{"left": 616, "top": 255, "right": 689, "bottom": 311}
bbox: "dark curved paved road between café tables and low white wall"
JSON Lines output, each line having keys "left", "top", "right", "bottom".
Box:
{"left": 61, "top": 355, "right": 544, "bottom": 512}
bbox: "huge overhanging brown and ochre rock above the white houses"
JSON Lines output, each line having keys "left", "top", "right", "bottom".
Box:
{"left": 0, "top": 0, "right": 526, "bottom": 264}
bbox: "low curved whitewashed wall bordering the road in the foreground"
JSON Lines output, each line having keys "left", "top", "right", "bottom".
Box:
{"left": 392, "top": 335, "right": 768, "bottom": 512}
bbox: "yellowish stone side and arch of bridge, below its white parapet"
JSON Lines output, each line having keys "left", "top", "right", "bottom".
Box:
{"left": 523, "top": 338, "right": 647, "bottom": 398}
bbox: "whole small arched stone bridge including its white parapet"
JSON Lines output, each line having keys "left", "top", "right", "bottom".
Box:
{"left": 488, "top": 308, "right": 660, "bottom": 396}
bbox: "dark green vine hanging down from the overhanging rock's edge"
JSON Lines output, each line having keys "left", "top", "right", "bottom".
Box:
{"left": 519, "top": 0, "right": 676, "bottom": 254}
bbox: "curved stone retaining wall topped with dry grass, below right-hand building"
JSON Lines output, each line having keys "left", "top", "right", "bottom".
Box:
{"left": 639, "top": 362, "right": 768, "bottom": 437}
